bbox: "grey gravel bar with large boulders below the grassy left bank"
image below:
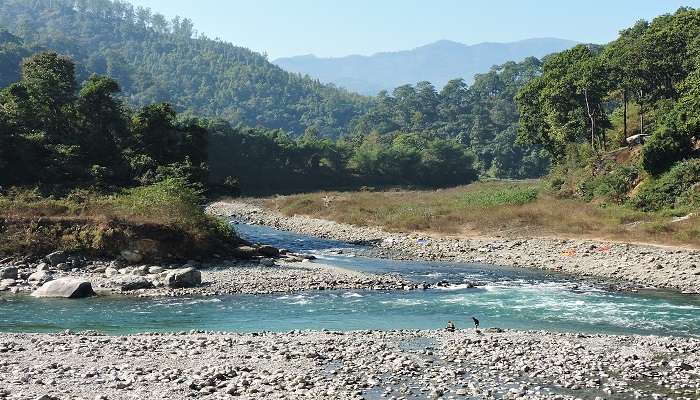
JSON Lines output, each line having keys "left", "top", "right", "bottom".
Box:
{"left": 0, "top": 250, "right": 418, "bottom": 297}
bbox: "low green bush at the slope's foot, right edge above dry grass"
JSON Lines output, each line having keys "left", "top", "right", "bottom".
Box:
{"left": 633, "top": 159, "right": 700, "bottom": 211}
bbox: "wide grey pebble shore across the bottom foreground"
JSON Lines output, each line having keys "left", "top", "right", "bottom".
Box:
{"left": 0, "top": 330, "right": 700, "bottom": 400}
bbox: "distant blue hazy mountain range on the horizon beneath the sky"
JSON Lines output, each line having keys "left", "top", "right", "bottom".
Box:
{"left": 273, "top": 38, "right": 577, "bottom": 95}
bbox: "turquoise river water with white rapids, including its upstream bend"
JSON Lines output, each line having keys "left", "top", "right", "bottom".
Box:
{"left": 0, "top": 226, "right": 700, "bottom": 336}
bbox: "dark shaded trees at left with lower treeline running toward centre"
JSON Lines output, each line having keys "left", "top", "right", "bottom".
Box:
{"left": 0, "top": 32, "right": 476, "bottom": 194}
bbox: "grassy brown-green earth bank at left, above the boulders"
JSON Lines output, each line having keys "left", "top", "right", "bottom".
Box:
{"left": 0, "top": 179, "right": 237, "bottom": 260}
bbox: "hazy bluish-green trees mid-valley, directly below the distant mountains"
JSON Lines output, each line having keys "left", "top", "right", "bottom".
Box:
{"left": 351, "top": 58, "right": 549, "bottom": 178}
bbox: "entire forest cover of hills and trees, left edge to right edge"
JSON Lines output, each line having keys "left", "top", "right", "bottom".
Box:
{"left": 0, "top": 0, "right": 700, "bottom": 203}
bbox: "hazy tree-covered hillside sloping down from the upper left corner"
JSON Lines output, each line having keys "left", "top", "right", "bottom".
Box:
{"left": 0, "top": 0, "right": 370, "bottom": 136}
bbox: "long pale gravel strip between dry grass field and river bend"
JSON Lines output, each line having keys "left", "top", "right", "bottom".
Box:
{"left": 207, "top": 201, "right": 700, "bottom": 294}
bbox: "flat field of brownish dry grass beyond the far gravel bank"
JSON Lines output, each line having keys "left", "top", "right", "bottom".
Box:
{"left": 267, "top": 181, "right": 700, "bottom": 248}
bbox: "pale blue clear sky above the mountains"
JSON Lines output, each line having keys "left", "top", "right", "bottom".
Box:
{"left": 126, "top": 0, "right": 700, "bottom": 59}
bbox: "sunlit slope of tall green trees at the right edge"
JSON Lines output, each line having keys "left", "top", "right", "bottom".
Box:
{"left": 517, "top": 8, "right": 700, "bottom": 210}
